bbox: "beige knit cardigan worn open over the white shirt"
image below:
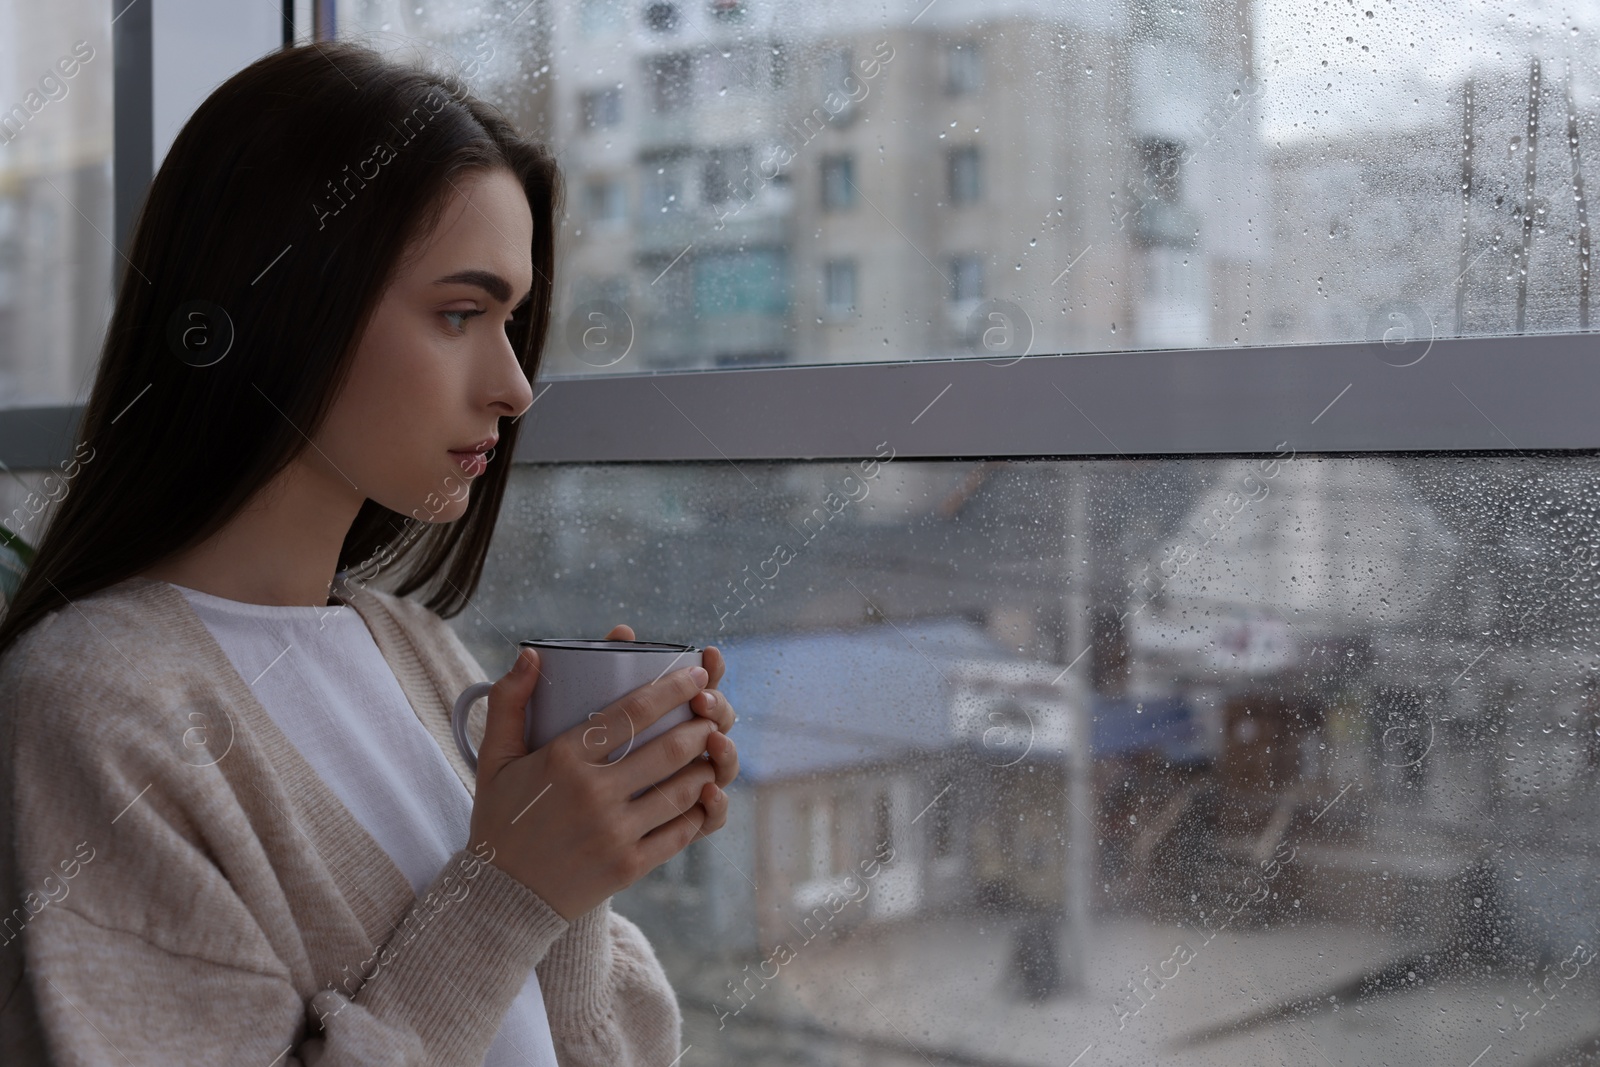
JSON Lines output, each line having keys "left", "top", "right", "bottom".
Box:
{"left": 0, "top": 577, "right": 682, "bottom": 1067}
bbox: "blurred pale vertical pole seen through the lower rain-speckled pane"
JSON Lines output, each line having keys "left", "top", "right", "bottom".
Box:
{"left": 1061, "top": 461, "right": 1094, "bottom": 992}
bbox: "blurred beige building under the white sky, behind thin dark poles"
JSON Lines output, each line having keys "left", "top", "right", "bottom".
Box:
{"left": 1262, "top": 62, "right": 1600, "bottom": 343}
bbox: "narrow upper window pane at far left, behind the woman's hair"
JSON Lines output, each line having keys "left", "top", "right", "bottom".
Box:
{"left": 0, "top": 0, "right": 118, "bottom": 406}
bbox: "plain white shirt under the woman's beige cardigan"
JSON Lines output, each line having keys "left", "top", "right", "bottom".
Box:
{"left": 174, "top": 585, "right": 557, "bottom": 1067}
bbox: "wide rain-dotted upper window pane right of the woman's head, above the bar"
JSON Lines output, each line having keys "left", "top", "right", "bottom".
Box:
{"left": 339, "top": 0, "right": 1600, "bottom": 374}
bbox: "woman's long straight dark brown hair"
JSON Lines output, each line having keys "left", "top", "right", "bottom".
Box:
{"left": 0, "top": 42, "right": 563, "bottom": 653}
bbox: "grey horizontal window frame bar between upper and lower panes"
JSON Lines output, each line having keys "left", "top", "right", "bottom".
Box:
{"left": 0, "top": 334, "right": 1600, "bottom": 470}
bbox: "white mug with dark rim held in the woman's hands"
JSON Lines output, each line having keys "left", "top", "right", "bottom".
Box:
{"left": 450, "top": 638, "right": 706, "bottom": 777}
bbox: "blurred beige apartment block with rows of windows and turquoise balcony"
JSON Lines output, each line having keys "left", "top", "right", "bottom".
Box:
{"left": 549, "top": 0, "right": 1266, "bottom": 373}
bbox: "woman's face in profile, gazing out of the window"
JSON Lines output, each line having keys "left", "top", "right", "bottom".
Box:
{"left": 304, "top": 170, "right": 533, "bottom": 522}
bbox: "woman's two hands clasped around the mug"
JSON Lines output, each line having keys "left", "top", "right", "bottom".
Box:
{"left": 469, "top": 648, "right": 723, "bottom": 921}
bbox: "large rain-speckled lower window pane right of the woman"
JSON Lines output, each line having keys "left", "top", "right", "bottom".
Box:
{"left": 453, "top": 457, "right": 1600, "bottom": 1067}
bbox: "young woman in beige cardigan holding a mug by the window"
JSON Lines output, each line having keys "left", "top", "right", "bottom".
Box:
{"left": 0, "top": 45, "right": 738, "bottom": 1067}
